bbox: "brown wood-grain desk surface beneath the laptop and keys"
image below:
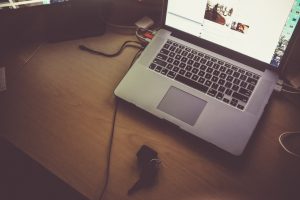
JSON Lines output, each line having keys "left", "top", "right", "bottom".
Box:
{"left": 0, "top": 32, "right": 300, "bottom": 200}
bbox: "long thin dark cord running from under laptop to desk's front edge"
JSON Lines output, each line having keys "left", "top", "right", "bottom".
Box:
{"left": 99, "top": 49, "right": 143, "bottom": 200}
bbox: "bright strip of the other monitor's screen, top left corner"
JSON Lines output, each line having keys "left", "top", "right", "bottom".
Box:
{"left": 0, "top": 0, "right": 68, "bottom": 9}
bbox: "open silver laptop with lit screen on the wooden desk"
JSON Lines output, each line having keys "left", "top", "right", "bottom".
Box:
{"left": 114, "top": 0, "right": 300, "bottom": 155}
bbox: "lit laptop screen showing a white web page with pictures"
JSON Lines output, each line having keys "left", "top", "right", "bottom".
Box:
{"left": 165, "top": 0, "right": 300, "bottom": 68}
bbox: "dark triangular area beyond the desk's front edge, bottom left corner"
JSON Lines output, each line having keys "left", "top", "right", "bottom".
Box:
{"left": 0, "top": 138, "right": 87, "bottom": 200}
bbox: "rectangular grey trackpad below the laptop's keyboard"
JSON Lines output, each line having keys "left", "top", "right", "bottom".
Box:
{"left": 157, "top": 87, "right": 207, "bottom": 126}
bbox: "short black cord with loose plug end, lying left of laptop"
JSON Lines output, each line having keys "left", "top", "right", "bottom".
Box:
{"left": 78, "top": 41, "right": 144, "bottom": 57}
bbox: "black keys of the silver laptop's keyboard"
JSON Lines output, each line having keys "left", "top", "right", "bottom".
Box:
{"left": 149, "top": 40, "right": 260, "bottom": 110}
